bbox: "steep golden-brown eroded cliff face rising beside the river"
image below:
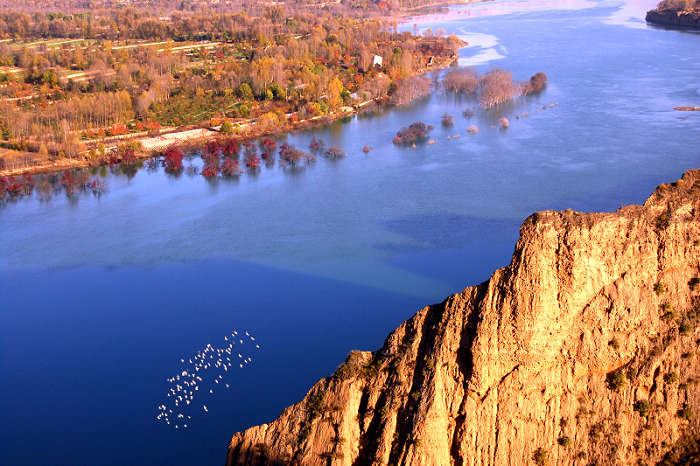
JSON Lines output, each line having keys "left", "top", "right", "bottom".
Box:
{"left": 228, "top": 170, "right": 700, "bottom": 465}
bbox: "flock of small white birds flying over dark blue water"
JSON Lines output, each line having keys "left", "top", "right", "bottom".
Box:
{"left": 156, "top": 330, "right": 260, "bottom": 429}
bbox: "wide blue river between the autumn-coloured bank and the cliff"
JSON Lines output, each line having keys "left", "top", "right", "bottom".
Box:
{"left": 0, "top": 2, "right": 700, "bottom": 465}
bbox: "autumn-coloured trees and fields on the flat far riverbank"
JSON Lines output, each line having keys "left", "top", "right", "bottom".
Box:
{"left": 0, "top": 2, "right": 464, "bottom": 174}
